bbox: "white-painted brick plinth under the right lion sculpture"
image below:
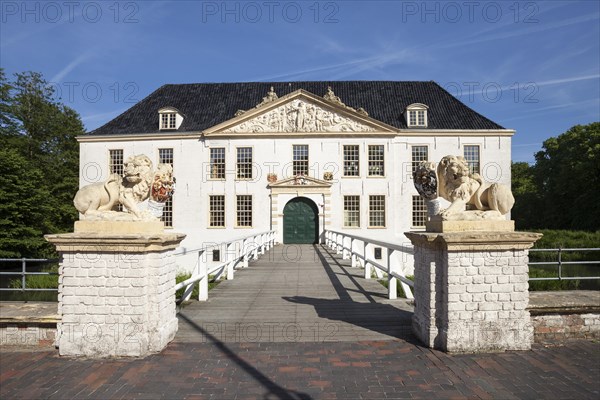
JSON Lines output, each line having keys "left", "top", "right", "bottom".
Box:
{"left": 406, "top": 232, "right": 541, "bottom": 352}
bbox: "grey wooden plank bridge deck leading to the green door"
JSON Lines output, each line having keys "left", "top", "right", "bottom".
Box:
{"left": 175, "top": 245, "right": 413, "bottom": 343}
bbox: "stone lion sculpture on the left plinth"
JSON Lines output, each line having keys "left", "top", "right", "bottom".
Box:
{"left": 73, "top": 155, "right": 154, "bottom": 219}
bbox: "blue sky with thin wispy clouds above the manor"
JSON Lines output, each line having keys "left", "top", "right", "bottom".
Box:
{"left": 0, "top": 1, "right": 600, "bottom": 162}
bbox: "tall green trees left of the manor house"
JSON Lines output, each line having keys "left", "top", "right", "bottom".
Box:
{"left": 0, "top": 69, "right": 84, "bottom": 257}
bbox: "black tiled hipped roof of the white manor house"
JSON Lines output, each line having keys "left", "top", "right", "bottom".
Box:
{"left": 88, "top": 81, "right": 504, "bottom": 135}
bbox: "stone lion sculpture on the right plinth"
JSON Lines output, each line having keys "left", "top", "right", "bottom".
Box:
{"left": 437, "top": 155, "right": 515, "bottom": 220}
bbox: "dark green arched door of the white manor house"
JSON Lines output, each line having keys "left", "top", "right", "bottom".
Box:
{"left": 283, "top": 197, "right": 319, "bottom": 244}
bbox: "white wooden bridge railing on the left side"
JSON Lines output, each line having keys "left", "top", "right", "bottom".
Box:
{"left": 175, "top": 231, "right": 275, "bottom": 301}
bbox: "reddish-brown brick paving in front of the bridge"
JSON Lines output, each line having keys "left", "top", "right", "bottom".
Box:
{"left": 0, "top": 340, "right": 600, "bottom": 399}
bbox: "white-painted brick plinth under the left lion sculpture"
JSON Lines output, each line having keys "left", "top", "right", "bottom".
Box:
{"left": 46, "top": 227, "right": 185, "bottom": 357}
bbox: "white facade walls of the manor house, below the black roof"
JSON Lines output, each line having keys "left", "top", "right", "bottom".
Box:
{"left": 79, "top": 91, "right": 514, "bottom": 269}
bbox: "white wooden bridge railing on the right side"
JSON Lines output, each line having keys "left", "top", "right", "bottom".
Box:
{"left": 325, "top": 230, "right": 414, "bottom": 299}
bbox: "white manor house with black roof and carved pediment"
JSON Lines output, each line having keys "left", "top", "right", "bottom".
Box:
{"left": 78, "top": 81, "right": 515, "bottom": 274}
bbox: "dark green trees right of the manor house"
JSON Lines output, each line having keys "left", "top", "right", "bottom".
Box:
{"left": 512, "top": 122, "right": 600, "bottom": 231}
